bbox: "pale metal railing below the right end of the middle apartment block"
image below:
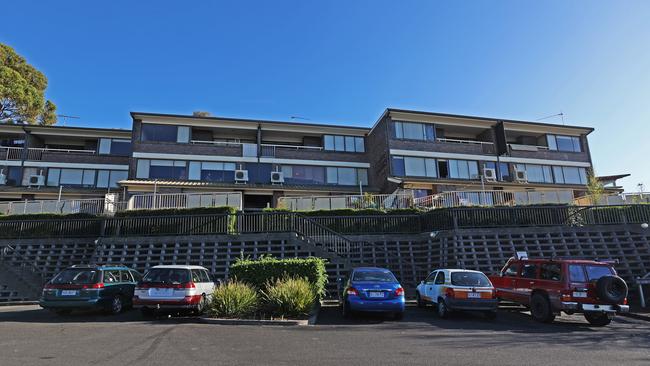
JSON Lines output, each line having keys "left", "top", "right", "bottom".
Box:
{"left": 278, "top": 193, "right": 413, "bottom": 211}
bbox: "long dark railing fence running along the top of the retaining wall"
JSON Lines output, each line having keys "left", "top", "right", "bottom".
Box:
{"left": 0, "top": 205, "right": 650, "bottom": 239}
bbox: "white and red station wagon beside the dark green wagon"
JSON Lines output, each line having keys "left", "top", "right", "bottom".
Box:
{"left": 133, "top": 265, "right": 215, "bottom": 316}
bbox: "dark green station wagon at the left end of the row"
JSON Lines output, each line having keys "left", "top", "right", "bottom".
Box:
{"left": 39, "top": 265, "right": 142, "bottom": 315}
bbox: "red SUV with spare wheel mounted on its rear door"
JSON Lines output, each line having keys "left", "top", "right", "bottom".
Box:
{"left": 490, "top": 258, "right": 630, "bottom": 326}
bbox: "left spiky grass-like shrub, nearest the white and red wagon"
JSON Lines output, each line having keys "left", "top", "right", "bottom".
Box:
{"left": 208, "top": 281, "right": 260, "bottom": 318}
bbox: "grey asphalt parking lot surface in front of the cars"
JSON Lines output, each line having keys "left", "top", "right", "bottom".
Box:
{"left": 0, "top": 306, "right": 650, "bottom": 366}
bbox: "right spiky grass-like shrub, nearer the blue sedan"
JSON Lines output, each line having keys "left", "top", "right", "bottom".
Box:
{"left": 262, "top": 278, "right": 318, "bottom": 317}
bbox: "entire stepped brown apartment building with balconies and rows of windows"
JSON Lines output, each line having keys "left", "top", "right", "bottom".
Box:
{"left": 0, "top": 109, "right": 593, "bottom": 208}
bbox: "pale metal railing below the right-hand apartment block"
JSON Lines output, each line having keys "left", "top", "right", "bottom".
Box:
{"left": 414, "top": 190, "right": 573, "bottom": 209}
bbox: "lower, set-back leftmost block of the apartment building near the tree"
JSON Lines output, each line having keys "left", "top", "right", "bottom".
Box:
{"left": 0, "top": 125, "right": 131, "bottom": 201}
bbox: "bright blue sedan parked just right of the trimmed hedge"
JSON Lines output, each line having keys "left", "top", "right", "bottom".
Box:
{"left": 339, "top": 267, "right": 406, "bottom": 320}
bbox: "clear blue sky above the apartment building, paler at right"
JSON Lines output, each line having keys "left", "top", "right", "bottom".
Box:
{"left": 0, "top": 0, "right": 650, "bottom": 191}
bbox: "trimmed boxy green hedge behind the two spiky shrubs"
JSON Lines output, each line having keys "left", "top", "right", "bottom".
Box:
{"left": 230, "top": 257, "right": 327, "bottom": 297}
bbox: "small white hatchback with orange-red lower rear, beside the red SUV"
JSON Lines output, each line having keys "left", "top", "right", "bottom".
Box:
{"left": 415, "top": 269, "right": 499, "bottom": 319}
